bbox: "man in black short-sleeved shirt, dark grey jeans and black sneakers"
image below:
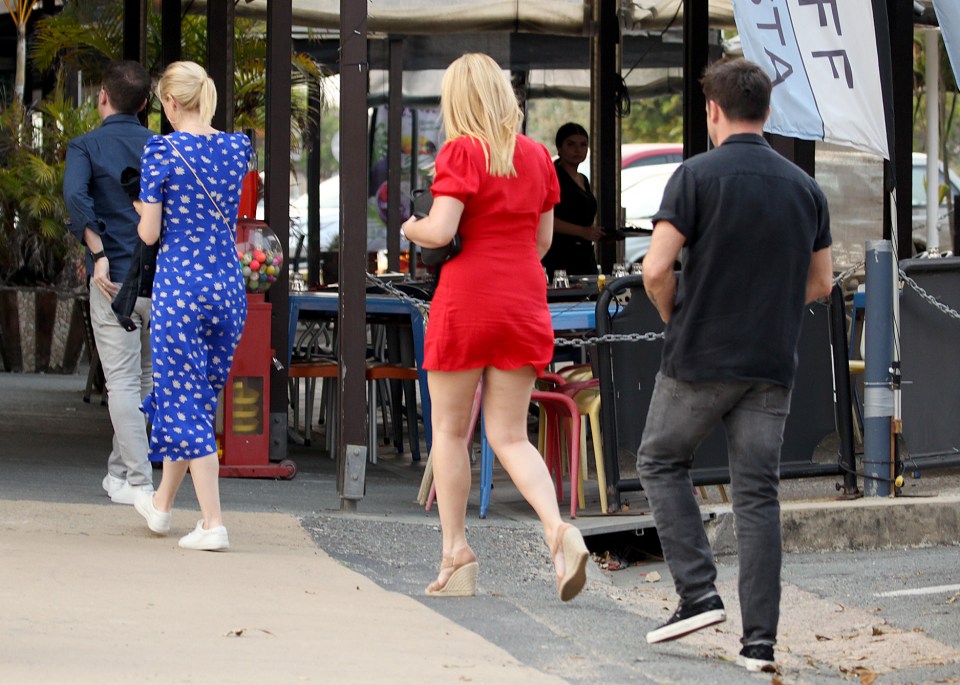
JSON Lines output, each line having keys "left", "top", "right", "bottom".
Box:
{"left": 637, "top": 59, "right": 833, "bottom": 671}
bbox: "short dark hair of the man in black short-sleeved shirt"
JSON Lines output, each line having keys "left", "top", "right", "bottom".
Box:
{"left": 700, "top": 58, "right": 773, "bottom": 121}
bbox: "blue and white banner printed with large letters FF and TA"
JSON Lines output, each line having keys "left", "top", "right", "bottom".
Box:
{"left": 733, "top": 0, "right": 892, "bottom": 159}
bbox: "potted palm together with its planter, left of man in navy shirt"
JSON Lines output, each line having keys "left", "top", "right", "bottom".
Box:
{"left": 0, "top": 90, "right": 97, "bottom": 373}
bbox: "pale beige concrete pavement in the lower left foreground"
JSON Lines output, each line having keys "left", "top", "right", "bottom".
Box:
{"left": 0, "top": 500, "right": 563, "bottom": 685}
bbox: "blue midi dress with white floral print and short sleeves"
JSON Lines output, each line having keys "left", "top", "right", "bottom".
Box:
{"left": 140, "top": 132, "right": 252, "bottom": 461}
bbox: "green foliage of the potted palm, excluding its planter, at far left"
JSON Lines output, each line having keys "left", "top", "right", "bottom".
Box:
{"left": 0, "top": 90, "right": 98, "bottom": 289}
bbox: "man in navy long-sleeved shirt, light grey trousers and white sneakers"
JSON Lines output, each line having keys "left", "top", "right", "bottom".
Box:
{"left": 63, "top": 61, "right": 153, "bottom": 504}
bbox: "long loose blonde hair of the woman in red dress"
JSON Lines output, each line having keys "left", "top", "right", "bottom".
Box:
{"left": 440, "top": 52, "right": 523, "bottom": 176}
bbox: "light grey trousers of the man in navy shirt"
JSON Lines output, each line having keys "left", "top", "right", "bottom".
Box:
{"left": 90, "top": 286, "right": 153, "bottom": 485}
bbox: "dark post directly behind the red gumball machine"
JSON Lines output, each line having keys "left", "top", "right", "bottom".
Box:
{"left": 264, "top": 0, "right": 293, "bottom": 461}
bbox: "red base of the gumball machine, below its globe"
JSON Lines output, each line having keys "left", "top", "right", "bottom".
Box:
{"left": 219, "top": 293, "right": 297, "bottom": 479}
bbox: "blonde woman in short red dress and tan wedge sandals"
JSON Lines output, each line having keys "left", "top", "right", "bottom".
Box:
{"left": 403, "top": 53, "right": 588, "bottom": 601}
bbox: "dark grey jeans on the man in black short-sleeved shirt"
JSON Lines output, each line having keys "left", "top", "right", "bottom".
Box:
{"left": 637, "top": 374, "right": 790, "bottom": 645}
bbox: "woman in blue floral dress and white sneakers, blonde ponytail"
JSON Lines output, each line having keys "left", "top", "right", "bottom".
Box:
{"left": 135, "top": 62, "right": 251, "bottom": 550}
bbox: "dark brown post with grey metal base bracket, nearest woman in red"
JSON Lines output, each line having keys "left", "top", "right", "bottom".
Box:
{"left": 336, "top": 0, "right": 370, "bottom": 502}
